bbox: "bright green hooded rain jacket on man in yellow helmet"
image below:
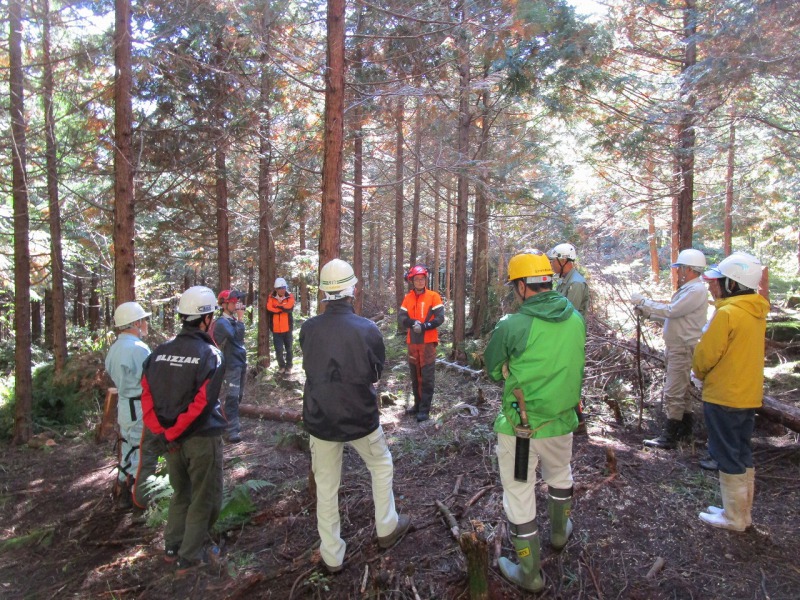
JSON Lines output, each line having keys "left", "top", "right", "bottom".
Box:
{"left": 484, "top": 291, "right": 586, "bottom": 438}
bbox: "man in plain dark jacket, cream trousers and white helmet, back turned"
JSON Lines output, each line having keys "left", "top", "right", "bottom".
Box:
{"left": 300, "top": 259, "right": 411, "bottom": 573}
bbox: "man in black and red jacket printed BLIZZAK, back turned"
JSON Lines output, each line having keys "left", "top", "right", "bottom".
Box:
{"left": 142, "top": 286, "right": 227, "bottom": 573}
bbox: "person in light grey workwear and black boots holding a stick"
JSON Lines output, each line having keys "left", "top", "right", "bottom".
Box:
{"left": 631, "top": 248, "right": 708, "bottom": 450}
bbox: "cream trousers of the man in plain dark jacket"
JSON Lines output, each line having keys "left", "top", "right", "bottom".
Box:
{"left": 310, "top": 426, "right": 398, "bottom": 567}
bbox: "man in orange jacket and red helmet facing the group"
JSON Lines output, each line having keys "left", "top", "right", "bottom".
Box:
{"left": 397, "top": 265, "right": 444, "bottom": 421}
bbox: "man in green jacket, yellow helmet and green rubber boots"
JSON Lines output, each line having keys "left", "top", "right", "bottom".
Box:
{"left": 484, "top": 250, "right": 586, "bottom": 592}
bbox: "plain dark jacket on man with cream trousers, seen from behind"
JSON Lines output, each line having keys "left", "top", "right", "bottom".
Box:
{"left": 300, "top": 300, "right": 386, "bottom": 442}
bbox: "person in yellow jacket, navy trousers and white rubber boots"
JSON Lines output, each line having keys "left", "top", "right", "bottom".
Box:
{"left": 692, "top": 252, "right": 769, "bottom": 531}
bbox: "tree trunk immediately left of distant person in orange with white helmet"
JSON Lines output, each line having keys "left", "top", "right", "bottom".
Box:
{"left": 255, "top": 10, "right": 275, "bottom": 372}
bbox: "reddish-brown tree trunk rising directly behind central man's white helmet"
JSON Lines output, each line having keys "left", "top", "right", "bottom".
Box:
{"left": 318, "top": 0, "right": 345, "bottom": 312}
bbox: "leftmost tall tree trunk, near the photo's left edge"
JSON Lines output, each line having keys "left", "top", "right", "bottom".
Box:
{"left": 8, "top": 0, "right": 33, "bottom": 444}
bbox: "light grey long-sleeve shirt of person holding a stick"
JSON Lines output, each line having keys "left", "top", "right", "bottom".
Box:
{"left": 640, "top": 277, "right": 708, "bottom": 346}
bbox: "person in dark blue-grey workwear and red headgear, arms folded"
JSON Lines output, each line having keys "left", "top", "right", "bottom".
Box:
{"left": 211, "top": 290, "right": 247, "bottom": 444}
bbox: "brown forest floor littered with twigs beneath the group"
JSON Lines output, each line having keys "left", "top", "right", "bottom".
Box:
{"left": 0, "top": 324, "right": 800, "bottom": 600}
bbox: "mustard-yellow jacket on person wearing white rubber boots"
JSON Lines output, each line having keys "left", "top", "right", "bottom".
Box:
{"left": 692, "top": 294, "right": 769, "bottom": 408}
